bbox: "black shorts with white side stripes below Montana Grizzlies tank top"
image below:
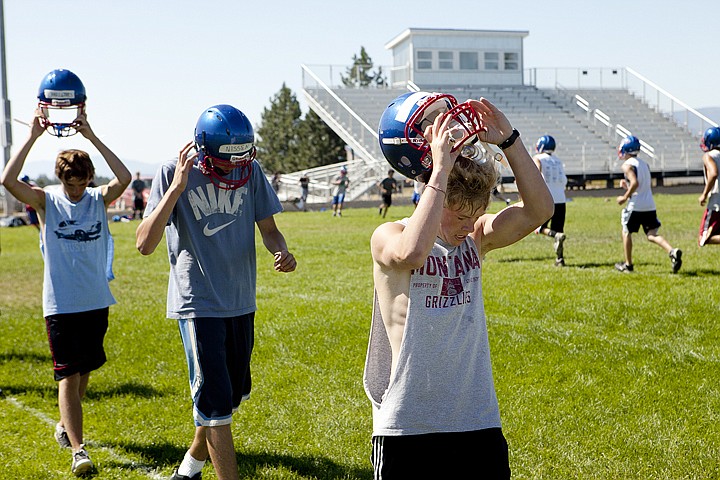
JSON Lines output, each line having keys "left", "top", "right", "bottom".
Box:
{"left": 370, "top": 428, "right": 510, "bottom": 480}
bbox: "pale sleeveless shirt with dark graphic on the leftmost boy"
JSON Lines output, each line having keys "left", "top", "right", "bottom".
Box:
{"left": 40, "top": 187, "right": 115, "bottom": 317}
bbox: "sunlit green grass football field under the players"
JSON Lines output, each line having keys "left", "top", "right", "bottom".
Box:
{"left": 0, "top": 194, "right": 720, "bottom": 480}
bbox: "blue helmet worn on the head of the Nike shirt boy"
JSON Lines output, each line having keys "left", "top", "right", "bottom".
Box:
{"left": 195, "top": 105, "right": 256, "bottom": 190}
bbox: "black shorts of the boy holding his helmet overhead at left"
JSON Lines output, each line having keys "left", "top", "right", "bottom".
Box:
{"left": 45, "top": 307, "right": 110, "bottom": 382}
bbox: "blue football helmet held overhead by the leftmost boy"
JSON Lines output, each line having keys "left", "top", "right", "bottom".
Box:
{"left": 38, "top": 69, "right": 87, "bottom": 137}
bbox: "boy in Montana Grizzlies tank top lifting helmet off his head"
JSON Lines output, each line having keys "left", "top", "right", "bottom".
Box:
{"left": 363, "top": 92, "right": 553, "bottom": 479}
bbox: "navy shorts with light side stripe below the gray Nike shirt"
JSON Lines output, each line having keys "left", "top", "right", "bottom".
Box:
{"left": 178, "top": 312, "right": 255, "bottom": 427}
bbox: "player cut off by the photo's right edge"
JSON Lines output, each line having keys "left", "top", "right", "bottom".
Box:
{"left": 698, "top": 127, "right": 720, "bottom": 247}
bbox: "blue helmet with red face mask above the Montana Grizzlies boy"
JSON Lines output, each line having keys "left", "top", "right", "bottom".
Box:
{"left": 378, "top": 92, "right": 485, "bottom": 178}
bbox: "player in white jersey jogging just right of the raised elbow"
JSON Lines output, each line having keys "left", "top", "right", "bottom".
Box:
{"left": 533, "top": 135, "right": 567, "bottom": 267}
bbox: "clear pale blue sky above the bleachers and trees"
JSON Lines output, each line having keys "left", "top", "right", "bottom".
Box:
{"left": 4, "top": 0, "right": 720, "bottom": 176}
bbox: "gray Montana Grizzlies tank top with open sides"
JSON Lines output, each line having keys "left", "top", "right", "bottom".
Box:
{"left": 363, "top": 232, "right": 500, "bottom": 436}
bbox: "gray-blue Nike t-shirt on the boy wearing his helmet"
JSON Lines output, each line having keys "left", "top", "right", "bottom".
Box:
{"left": 144, "top": 160, "right": 282, "bottom": 318}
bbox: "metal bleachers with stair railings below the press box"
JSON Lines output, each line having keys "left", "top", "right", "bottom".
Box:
{"left": 292, "top": 66, "right": 702, "bottom": 203}
